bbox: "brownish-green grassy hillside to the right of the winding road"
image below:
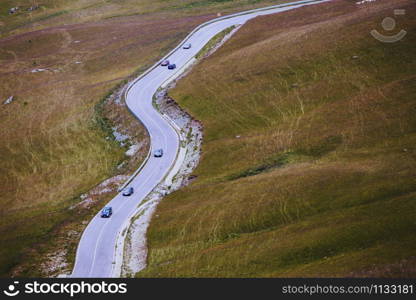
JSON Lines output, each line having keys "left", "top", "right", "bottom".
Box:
{"left": 138, "top": 0, "right": 416, "bottom": 277}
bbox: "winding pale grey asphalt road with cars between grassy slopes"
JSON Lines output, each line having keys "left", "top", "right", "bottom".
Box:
{"left": 71, "top": 0, "right": 330, "bottom": 278}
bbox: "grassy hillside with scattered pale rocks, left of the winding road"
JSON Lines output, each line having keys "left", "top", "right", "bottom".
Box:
{"left": 0, "top": 0, "right": 290, "bottom": 276}
